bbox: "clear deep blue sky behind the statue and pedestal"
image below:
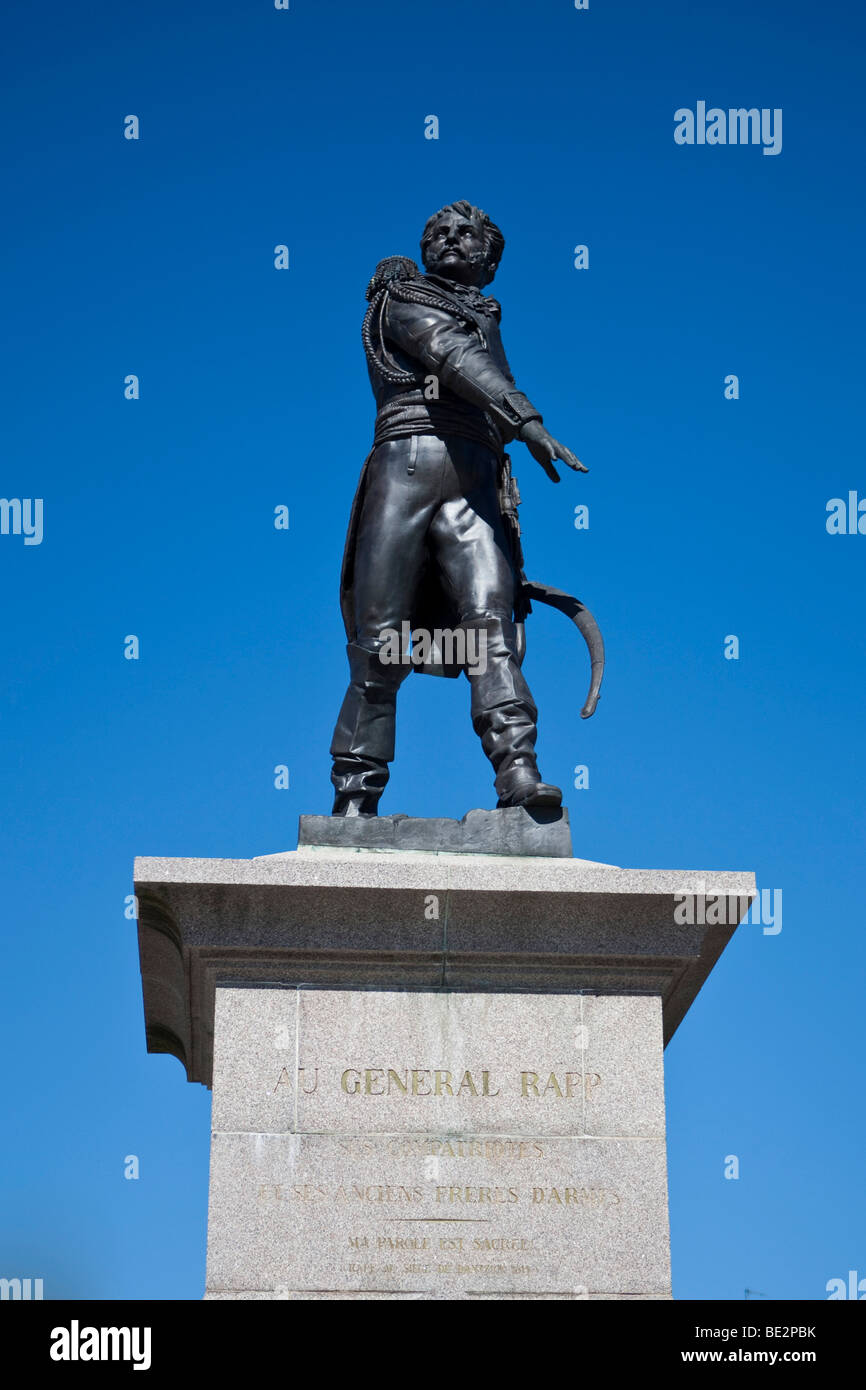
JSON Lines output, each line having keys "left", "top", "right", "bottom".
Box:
{"left": 0, "top": 0, "right": 866, "bottom": 1300}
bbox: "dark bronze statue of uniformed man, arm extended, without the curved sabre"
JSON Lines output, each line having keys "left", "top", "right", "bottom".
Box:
{"left": 331, "top": 202, "right": 587, "bottom": 816}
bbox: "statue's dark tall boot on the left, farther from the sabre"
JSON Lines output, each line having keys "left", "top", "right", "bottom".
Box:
{"left": 331, "top": 642, "right": 409, "bottom": 816}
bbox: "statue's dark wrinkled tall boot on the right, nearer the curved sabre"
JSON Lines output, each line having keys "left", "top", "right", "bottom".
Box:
{"left": 460, "top": 617, "right": 562, "bottom": 808}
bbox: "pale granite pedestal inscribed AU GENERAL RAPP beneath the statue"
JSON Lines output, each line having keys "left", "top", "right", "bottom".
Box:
{"left": 136, "top": 812, "right": 755, "bottom": 1300}
